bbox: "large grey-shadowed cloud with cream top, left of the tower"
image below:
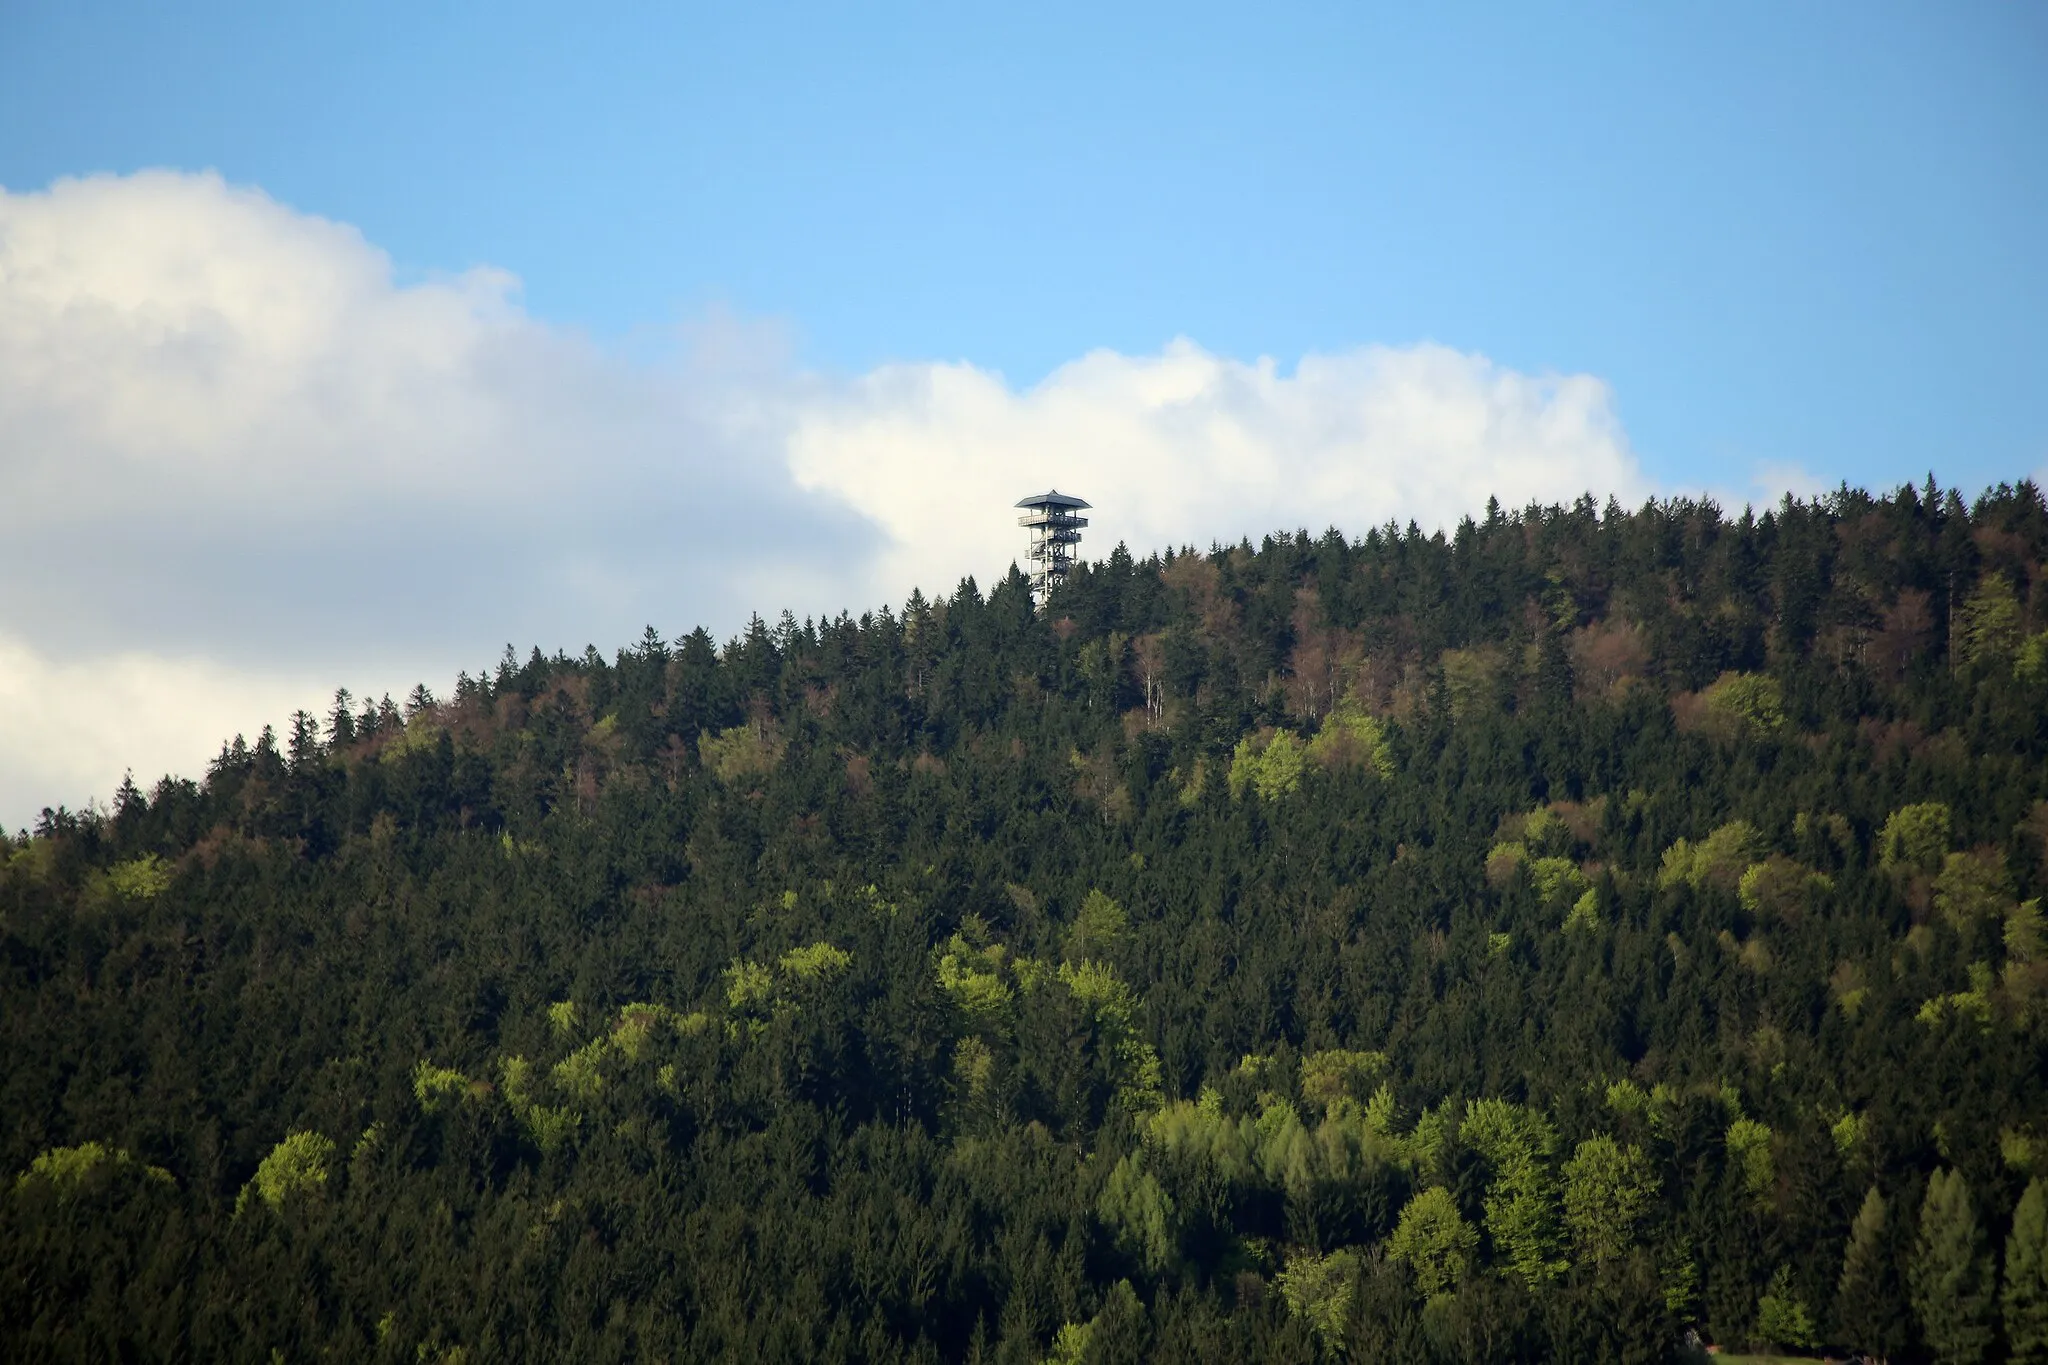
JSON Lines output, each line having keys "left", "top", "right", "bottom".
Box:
{"left": 0, "top": 172, "right": 872, "bottom": 669}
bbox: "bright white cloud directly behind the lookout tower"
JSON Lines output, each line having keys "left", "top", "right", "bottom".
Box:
{"left": 791, "top": 340, "right": 1647, "bottom": 589}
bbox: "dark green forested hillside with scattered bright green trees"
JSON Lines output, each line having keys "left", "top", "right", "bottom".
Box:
{"left": 12, "top": 479, "right": 2048, "bottom": 1365}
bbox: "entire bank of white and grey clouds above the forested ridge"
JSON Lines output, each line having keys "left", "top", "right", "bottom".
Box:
{"left": 0, "top": 172, "right": 1651, "bottom": 827}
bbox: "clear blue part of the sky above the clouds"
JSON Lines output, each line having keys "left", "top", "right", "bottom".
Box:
{"left": 0, "top": 0, "right": 2048, "bottom": 485}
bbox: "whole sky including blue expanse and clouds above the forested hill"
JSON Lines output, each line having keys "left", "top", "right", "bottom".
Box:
{"left": 0, "top": 0, "right": 2048, "bottom": 827}
